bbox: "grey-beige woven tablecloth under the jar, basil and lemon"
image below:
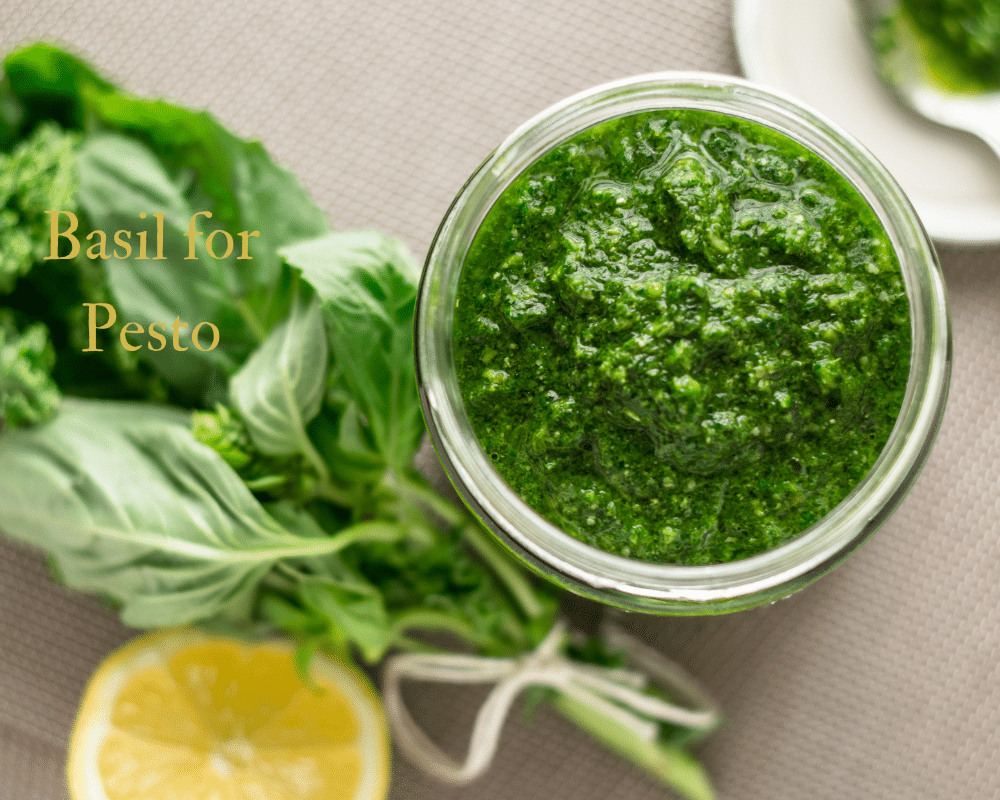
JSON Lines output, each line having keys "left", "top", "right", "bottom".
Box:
{"left": 0, "top": 0, "right": 1000, "bottom": 800}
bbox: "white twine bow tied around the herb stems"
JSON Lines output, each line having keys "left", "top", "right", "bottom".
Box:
{"left": 383, "top": 621, "right": 720, "bottom": 784}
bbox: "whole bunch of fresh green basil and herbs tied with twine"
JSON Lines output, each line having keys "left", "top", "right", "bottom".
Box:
{"left": 0, "top": 45, "right": 711, "bottom": 798}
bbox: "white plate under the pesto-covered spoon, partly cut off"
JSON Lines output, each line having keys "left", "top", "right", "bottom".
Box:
{"left": 733, "top": 0, "right": 1000, "bottom": 244}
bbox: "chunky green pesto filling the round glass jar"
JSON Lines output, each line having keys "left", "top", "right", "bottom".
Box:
{"left": 455, "top": 110, "right": 910, "bottom": 564}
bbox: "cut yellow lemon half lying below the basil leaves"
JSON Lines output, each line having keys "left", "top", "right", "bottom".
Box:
{"left": 68, "top": 630, "right": 389, "bottom": 800}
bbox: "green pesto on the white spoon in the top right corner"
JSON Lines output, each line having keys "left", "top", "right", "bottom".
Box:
{"left": 901, "top": 0, "right": 1000, "bottom": 91}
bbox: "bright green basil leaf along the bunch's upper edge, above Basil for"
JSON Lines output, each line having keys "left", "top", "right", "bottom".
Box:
{"left": 0, "top": 44, "right": 329, "bottom": 294}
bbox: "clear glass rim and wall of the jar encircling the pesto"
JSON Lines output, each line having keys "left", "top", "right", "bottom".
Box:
{"left": 416, "top": 72, "right": 951, "bottom": 615}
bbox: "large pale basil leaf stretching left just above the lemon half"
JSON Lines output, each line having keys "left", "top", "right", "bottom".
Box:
{"left": 0, "top": 400, "right": 370, "bottom": 627}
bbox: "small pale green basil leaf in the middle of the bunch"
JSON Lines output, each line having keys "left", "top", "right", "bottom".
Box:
{"left": 229, "top": 297, "right": 329, "bottom": 456}
